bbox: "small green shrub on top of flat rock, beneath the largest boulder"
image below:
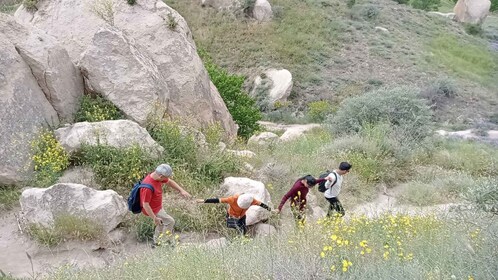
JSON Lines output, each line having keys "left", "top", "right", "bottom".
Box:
{"left": 75, "top": 95, "right": 124, "bottom": 122}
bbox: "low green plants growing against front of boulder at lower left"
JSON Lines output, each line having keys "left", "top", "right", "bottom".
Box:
{"left": 28, "top": 215, "right": 103, "bottom": 247}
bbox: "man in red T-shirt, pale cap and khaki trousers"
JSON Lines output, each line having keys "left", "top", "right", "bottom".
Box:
{"left": 140, "top": 164, "right": 191, "bottom": 248}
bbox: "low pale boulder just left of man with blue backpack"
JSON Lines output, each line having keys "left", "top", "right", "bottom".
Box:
{"left": 20, "top": 184, "right": 128, "bottom": 232}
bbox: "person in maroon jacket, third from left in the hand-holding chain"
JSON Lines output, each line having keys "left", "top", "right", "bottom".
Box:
{"left": 277, "top": 175, "right": 326, "bottom": 223}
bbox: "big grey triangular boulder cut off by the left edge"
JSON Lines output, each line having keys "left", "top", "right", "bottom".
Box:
{"left": 0, "top": 32, "right": 59, "bottom": 185}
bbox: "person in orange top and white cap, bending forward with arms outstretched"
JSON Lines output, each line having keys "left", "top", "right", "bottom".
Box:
{"left": 196, "top": 193, "right": 271, "bottom": 235}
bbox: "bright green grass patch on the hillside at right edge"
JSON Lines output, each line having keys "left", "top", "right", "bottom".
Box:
{"left": 430, "top": 35, "right": 497, "bottom": 82}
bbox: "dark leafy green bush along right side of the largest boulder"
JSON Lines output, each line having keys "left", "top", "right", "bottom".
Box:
{"left": 199, "top": 51, "right": 261, "bottom": 138}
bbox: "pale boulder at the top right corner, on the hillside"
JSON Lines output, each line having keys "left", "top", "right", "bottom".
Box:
{"left": 453, "top": 0, "right": 491, "bottom": 24}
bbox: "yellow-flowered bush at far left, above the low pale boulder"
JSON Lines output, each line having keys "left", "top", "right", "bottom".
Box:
{"left": 31, "top": 130, "right": 69, "bottom": 187}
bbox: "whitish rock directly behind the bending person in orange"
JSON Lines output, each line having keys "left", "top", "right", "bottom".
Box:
{"left": 221, "top": 177, "right": 272, "bottom": 225}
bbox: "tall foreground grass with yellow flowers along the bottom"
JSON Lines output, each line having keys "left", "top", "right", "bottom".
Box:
{"left": 44, "top": 215, "right": 498, "bottom": 279}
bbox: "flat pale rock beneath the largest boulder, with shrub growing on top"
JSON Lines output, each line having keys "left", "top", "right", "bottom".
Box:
{"left": 55, "top": 120, "right": 164, "bottom": 156}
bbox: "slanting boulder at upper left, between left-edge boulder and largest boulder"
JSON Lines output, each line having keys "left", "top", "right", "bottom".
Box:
{"left": 0, "top": 14, "right": 84, "bottom": 121}
